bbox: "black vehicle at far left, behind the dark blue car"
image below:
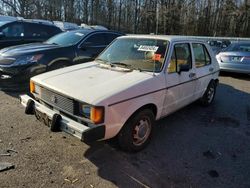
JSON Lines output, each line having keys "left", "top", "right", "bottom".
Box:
{"left": 0, "top": 20, "right": 62, "bottom": 49}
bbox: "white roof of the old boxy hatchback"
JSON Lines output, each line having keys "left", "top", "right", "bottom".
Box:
{"left": 119, "top": 34, "right": 206, "bottom": 43}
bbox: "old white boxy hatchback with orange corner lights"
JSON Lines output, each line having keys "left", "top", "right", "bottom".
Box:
{"left": 21, "top": 35, "right": 219, "bottom": 151}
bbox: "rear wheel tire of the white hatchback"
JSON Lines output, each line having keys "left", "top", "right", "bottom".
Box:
{"left": 200, "top": 80, "right": 217, "bottom": 106}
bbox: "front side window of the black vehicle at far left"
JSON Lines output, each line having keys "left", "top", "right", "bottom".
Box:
{"left": 2, "top": 23, "right": 24, "bottom": 37}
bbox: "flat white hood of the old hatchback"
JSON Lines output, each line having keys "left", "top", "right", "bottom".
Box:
{"left": 32, "top": 62, "right": 154, "bottom": 105}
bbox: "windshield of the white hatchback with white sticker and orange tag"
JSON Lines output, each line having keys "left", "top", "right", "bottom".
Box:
{"left": 97, "top": 38, "right": 168, "bottom": 72}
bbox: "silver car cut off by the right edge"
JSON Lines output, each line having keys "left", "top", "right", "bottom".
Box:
{"left": 216, "top": 41, "right": 250, "bottom": 74}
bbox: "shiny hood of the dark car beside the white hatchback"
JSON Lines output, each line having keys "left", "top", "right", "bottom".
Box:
{"left": 0, "top": 43, "right": 60, "bottom": 57}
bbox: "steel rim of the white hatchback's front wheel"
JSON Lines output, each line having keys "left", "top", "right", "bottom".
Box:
{"left": 133, "top": 117, "right": 151, "bottom": 146}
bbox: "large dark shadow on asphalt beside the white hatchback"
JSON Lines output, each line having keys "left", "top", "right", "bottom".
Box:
{"left": 83, "top": 84, "right": 250, "bottom": 188}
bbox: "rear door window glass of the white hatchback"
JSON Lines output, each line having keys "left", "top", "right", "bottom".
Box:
{"left": 192, "top": 43, "right": 211, "bottom": 68}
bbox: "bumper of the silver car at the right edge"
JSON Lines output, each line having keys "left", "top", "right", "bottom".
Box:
{"left": 219, "top": 63, "right": 250, "bottom": 74}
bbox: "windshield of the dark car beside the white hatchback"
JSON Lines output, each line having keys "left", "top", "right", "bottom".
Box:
{"left": 45, "top": 31, "right": 84, "bottom": 46}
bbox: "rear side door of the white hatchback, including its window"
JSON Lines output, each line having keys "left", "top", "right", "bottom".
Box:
{"left": 192, "top": 43, "right": 213, "bottom": 98}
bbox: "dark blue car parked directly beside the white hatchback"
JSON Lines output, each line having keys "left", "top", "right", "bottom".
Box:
{"left": 0, "top": 29, "right": 123, "bottom": 90}
